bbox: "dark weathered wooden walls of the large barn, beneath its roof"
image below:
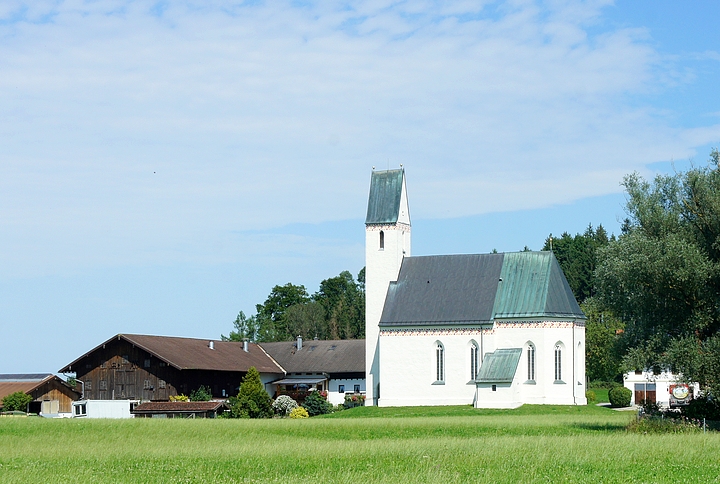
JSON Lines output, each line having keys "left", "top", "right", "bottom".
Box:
{"left": 74, "top": 340, "right": 245, "bottom": 401}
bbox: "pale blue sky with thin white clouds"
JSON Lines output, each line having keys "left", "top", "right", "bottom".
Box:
{"left": 0, "top": 0, "right": 720, "bottom": 373}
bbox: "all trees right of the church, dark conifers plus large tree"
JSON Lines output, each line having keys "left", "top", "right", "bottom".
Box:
{"left": 544, "top": 149, "right": 720, "bottom": 395}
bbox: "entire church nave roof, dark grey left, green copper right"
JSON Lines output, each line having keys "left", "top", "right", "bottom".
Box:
{"left": 380, "top": 252, "right": 585, "bottom": 326}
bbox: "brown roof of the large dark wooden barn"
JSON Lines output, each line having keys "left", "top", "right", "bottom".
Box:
{"left": 60, "top": 334, "right": 284, "bottom": 373}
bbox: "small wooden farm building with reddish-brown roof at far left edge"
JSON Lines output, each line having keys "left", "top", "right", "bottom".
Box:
{"left": 0, "top": 373, "right": 80, "bottom": 417}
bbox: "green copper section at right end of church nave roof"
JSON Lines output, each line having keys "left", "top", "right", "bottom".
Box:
{"left": 493, "top": 252, "right": 582, "bottom": 319}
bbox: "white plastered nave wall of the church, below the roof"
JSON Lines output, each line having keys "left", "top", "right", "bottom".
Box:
{"left": 379, "top": 321, "right": 587, "bottom": 408}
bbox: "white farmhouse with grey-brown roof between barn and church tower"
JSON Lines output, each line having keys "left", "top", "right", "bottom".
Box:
{"left": 260, "top": 337, "right": 365, "bottom": 405}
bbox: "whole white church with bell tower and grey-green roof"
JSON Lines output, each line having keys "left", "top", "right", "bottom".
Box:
{"left": 365, "top": 169, "right": 587, "bottom": 408}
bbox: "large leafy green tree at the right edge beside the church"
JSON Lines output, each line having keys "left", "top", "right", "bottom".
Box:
{"left": 596, "top": 149, "right": 720, "bottom": 395}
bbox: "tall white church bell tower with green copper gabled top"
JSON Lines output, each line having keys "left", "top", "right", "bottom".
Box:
{"left": 365, "top": 168, "right": 410, "bottom": 405}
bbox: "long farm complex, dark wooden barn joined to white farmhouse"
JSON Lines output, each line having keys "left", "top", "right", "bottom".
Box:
{"left": 60, "top": 334, "right": 365, "bottom": 408}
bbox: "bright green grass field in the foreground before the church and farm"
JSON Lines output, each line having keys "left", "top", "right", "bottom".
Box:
{"left": 0, "top": 406, "right": 720, "bottom": 483}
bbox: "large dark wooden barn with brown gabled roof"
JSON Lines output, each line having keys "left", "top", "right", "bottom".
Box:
{"left": 60, "top": 334, "right": 285, "bottom": 401}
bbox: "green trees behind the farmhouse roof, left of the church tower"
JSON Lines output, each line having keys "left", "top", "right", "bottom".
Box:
{"left": 221, "top": 268, "right": 365, "bottom": 342}
